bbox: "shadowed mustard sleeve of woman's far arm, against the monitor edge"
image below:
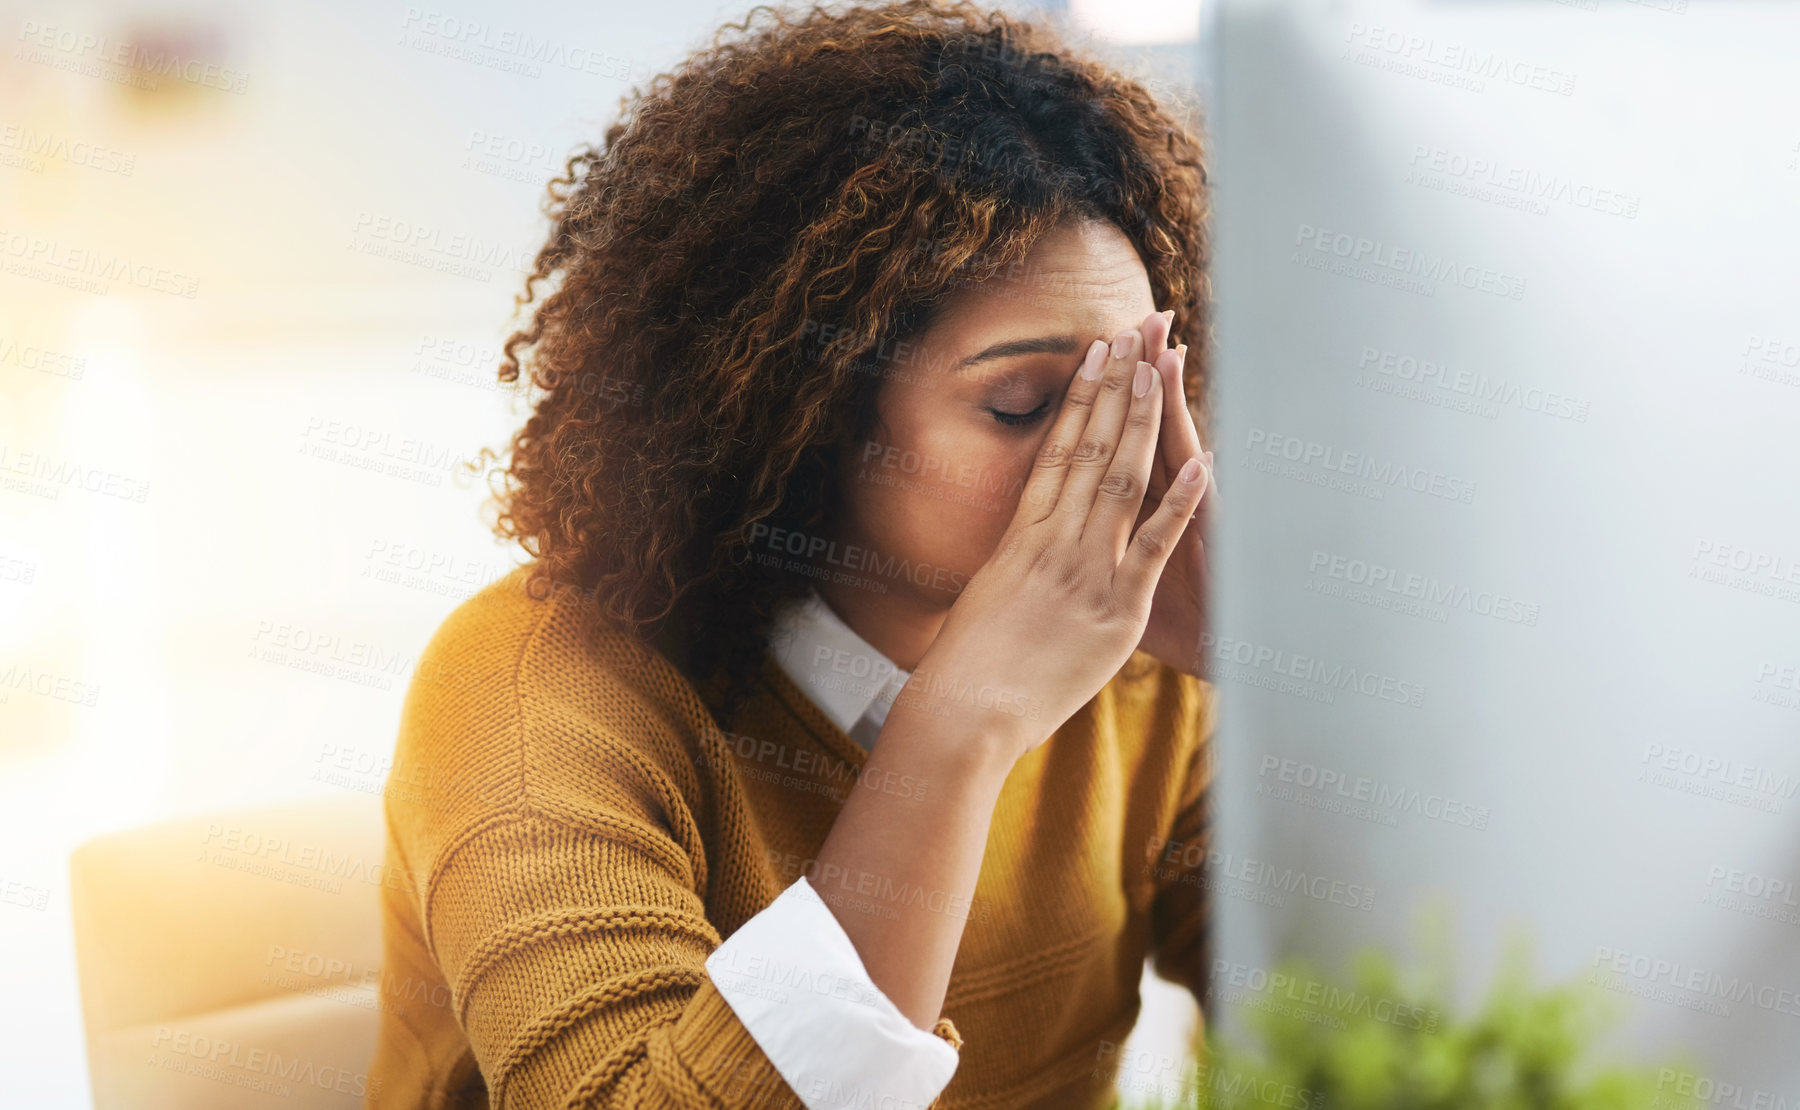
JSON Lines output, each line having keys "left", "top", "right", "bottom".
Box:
{"left": 1150, "top": 684, "right": 1213, "bottom": 1007}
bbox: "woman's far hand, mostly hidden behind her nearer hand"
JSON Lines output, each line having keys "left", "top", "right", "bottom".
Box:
{"left": 1138, "top": 311, "right": 1219, "bottom": 676}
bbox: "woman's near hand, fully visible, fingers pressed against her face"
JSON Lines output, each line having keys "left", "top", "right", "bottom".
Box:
{"left": 895, "top": 317, "right": 1206, "bottom": 759}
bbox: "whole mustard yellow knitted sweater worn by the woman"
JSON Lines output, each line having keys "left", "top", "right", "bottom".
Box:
{"left": 367, "top": 568, "right": 1213, "bottom": 1110}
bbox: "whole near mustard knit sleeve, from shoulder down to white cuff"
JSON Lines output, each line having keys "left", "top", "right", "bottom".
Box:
{"left": 387, "top": 586, "right": 954, "bottom": 1110}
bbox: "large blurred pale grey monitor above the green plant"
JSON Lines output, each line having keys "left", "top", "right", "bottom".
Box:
{"left": 1210, "top": 0, "right": 1800, "bottom": 1106}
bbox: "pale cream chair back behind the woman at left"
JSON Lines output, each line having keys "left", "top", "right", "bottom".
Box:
{"left": 70, "top": 793, "right": 387, "bottom": 1110}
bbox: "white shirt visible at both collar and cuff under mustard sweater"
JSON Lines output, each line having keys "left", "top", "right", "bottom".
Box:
{"left": 706, "top": 590, "right": 959, "bottom": 1110}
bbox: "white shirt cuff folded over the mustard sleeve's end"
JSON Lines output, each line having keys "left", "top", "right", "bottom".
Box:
{"left": 706, "top": 876, "right": 959, "bottom": 1110}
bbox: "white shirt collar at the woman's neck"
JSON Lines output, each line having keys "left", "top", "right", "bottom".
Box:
{"left": 769, "top": 586, "right": 913, "bottom": 747}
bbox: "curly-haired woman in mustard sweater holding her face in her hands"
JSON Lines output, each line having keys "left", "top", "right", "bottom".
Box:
{"left": 369, "top": 0, "right": 1211, "bottom": 1110}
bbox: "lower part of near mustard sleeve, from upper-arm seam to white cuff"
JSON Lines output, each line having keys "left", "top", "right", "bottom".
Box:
{"left": 425, "top": 802, "right": 803, "bottom": 1110}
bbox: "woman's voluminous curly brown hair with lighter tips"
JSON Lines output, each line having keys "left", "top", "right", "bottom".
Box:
{"left": 490, "top": 0, "right": 1210, "bottom": 720}
